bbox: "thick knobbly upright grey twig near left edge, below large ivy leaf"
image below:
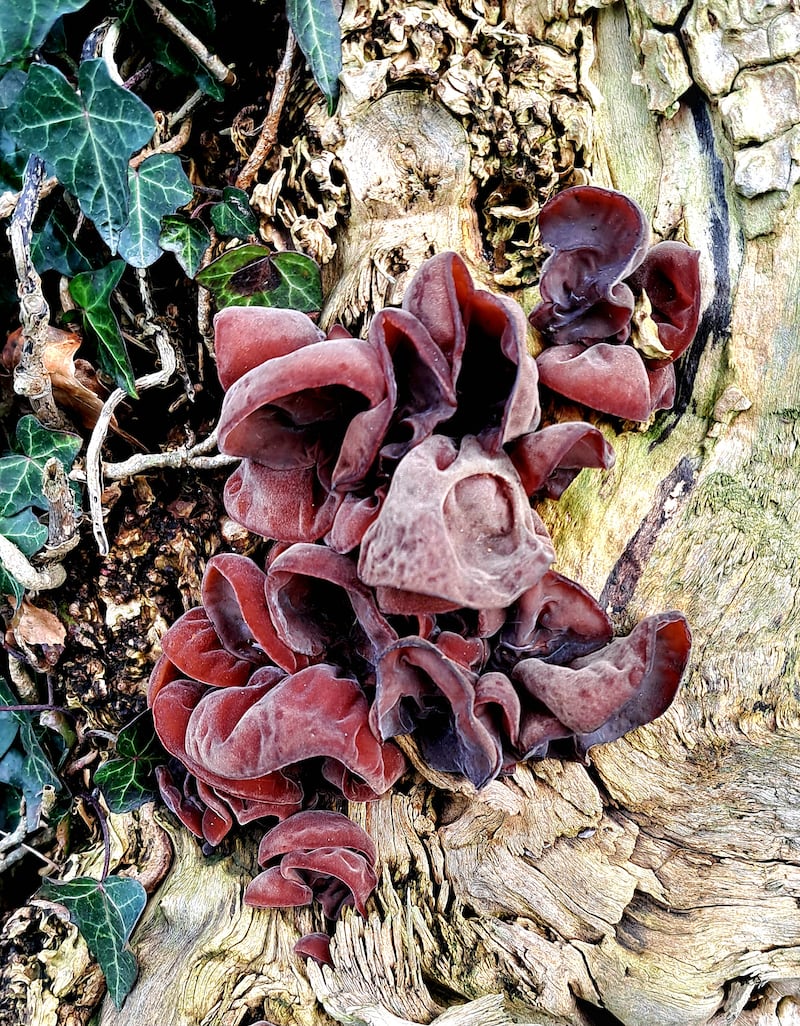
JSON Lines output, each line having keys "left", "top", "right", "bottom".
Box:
{"left": 8, "top": 156, "right": 63, "bottom": 427}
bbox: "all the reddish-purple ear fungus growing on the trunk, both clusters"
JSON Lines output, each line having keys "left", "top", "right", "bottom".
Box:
{"left": 149, "top": 187, "right": 699, "bottom": 961}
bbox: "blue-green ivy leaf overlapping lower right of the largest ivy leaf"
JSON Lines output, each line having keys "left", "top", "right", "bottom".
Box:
{"left": 119, "top": 153, "right": 194, "bottom": 267}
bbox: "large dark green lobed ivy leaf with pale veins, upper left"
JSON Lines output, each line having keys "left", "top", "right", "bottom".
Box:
{"left": 5, "top": 60, "right": 155, "bottom": 252}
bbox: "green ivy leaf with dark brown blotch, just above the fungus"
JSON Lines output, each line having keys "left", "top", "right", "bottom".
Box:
{"left": 197, "top": 243, "right": 322, "bottom": 313}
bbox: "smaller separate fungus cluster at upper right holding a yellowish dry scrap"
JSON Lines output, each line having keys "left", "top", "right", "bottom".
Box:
{"left": 530, "top": 186, "right": 701, "bottom": 421}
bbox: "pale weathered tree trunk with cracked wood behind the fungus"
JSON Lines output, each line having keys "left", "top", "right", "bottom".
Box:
{"left": 14, "top": 0, "right": 800, "bottom": 1026}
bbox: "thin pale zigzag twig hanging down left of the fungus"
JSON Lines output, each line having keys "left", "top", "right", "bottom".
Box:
{"left": 86, "top": 269, "right": 177, "bottom": 556}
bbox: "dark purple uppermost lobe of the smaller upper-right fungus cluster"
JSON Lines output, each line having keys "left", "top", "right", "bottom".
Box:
{"left": 530, "top": 186, "right": 649, "bottom": 344}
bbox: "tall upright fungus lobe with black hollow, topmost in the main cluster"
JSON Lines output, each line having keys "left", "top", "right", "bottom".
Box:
{"left": 403, "top": 252, "right": 539, "bottom": 455}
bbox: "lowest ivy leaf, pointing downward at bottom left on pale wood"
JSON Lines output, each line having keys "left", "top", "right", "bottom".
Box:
{"left": 38, "top": 876, "right": 147, "bottom": 1009}
